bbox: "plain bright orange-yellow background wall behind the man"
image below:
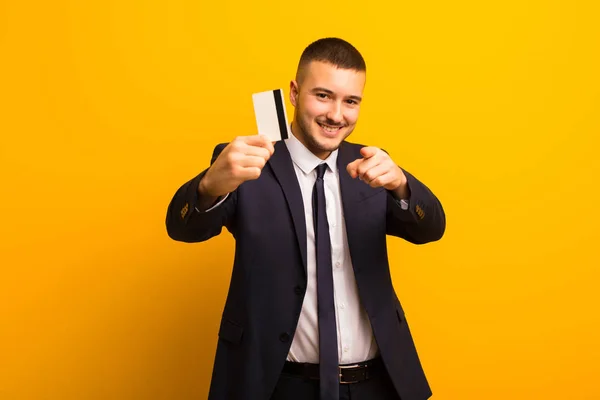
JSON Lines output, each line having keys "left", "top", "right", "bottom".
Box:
{"left": 0, "top": 0, "right": 600, "bottom": 400}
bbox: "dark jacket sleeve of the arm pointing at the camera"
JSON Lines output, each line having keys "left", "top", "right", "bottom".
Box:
{"left": 386, "top": 169, "right": 446, "bottom": 244}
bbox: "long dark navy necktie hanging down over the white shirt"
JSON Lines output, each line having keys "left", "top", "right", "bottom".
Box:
{"left": 313, "top": 164, "right": 340, "bottom": 400}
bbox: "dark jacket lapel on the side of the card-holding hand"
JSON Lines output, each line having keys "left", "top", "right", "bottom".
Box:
{"left": 269, "top": 140, "right": 307, "bottom": 274}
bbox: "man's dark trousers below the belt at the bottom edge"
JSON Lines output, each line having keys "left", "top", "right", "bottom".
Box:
{"left": 271, "top": 371, "right": 400, "bottom": 400}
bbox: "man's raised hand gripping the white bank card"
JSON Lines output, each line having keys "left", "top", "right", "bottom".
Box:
{"left": 198, "top": 135, "right": 275, "bottom": 198}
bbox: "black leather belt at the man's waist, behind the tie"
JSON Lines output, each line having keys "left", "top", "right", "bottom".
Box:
{"left": 283, "top": 358, "right": 384, "bottom": 383}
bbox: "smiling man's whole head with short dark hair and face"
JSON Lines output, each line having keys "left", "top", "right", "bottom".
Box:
{"left": 290, "top": 38, "right": 367, "bottom": 159}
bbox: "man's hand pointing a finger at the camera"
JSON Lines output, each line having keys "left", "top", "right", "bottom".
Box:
{"left": 346, "top": 147, "right": 410, "bottom": 199}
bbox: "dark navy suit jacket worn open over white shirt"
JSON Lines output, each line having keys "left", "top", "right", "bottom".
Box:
{"left": 166, "top": 141, "right": 446, "bottom": 400}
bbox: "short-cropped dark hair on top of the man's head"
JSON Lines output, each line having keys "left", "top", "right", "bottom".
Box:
{"left": 298, "top": 37, "right": 367, "bottom": 81}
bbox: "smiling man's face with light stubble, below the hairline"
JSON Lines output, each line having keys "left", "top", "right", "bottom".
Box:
{"left": 290, "top": 61, "right": 365, "bottom": 159}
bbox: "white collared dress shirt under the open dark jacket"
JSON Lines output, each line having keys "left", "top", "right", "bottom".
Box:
{"left": 285, "top": 134, "right": 378, "bottom": 364}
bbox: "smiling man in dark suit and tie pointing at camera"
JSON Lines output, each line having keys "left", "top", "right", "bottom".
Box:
{"left": 166, "top": 38, "right": 445, "bottom": 400}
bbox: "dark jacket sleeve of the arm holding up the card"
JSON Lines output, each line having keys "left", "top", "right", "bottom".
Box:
{"left": 166, "top": 143, "right": 237, "bottom": 243}
